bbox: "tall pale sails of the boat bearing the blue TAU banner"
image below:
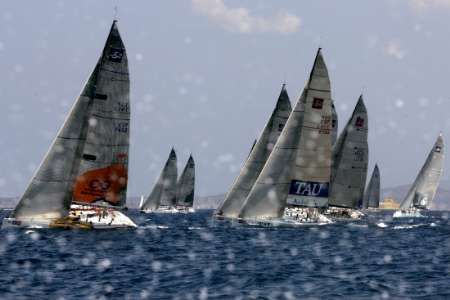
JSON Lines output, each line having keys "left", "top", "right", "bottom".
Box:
{"left": 240, "top": 49, "right": 331, "bottom": 218}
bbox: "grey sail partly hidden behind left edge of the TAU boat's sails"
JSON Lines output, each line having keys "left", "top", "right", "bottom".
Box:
{"left": 216, "top": 84, "right": 292, "bottom": 218}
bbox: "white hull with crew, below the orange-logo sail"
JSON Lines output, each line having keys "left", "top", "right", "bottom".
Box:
{"left": 70, "top": 204, "right": 137, "bottom": 229}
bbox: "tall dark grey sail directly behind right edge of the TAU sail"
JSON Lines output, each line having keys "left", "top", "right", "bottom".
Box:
{"left": 329, "top": 95, "right": 369, "bottom": 208}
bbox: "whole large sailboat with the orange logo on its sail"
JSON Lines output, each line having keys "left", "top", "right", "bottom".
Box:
{"left": 3, "top": 21, "right": 136, "bottom": 228}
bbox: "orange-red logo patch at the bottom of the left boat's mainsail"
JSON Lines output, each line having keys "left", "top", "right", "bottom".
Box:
{"left": 73, "top": 164, "right": 127, "bottom": 205}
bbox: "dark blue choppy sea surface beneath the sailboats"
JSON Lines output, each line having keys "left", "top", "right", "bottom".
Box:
{"left": 0, "top": 210, "right": 450, "bottom": 299}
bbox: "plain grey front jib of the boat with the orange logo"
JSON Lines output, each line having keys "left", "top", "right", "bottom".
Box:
{"left": 11, "top": 72, "right": 97, "bottom": 222}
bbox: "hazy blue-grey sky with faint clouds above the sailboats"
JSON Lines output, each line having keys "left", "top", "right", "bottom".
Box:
{"left": 0, "top": 0, "right": 450, "bottom": 196}
